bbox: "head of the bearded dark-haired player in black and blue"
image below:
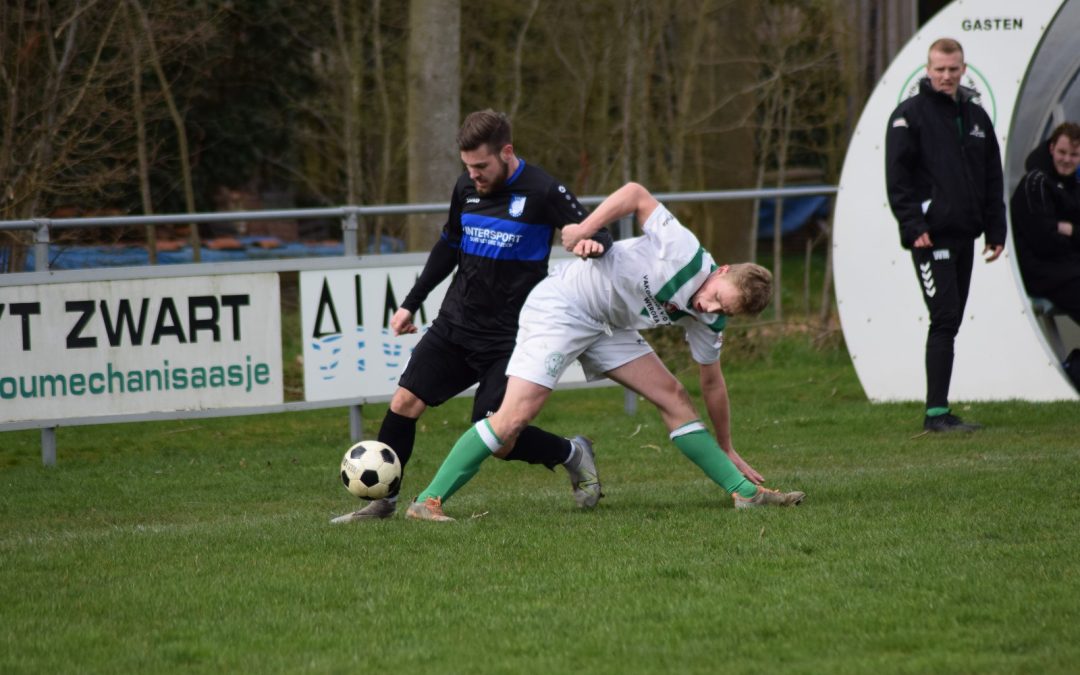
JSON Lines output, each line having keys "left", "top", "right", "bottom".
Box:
{"left": 458, "top": 108, "right": 514, "bottom": 194}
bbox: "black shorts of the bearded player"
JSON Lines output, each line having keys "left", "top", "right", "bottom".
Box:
{"left": 397, "top": 330, "right": 510, "bottom": 422}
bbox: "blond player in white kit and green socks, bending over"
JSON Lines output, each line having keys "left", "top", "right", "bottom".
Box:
{"left": 407, "top": 183, "right": 805, "bottom": 521}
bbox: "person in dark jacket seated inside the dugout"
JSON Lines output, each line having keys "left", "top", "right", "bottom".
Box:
{"left": 1010, "top": 122, "right": 1080, "bottom": 324}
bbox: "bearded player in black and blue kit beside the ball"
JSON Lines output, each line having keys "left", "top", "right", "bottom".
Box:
{"left": 332, "top": 109, "right": 612, "bottom": 523}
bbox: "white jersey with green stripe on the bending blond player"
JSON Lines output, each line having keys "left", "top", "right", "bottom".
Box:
{"left": 556, "top": 204, "right": 726, "bottom": 363}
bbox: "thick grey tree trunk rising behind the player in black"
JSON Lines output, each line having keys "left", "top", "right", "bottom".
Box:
{"left": 405, "top": 0, "right": 461, "bottom": 251}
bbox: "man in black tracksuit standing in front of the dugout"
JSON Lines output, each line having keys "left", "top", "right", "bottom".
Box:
{"left": 886, "top": 38, "right": 1005, "bottom": 431}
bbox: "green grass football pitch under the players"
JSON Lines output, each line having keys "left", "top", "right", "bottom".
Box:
{"left": 0, "top": 337, "right": 1080, "bottom": 674}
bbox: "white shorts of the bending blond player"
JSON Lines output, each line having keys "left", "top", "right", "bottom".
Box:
{"left": 507, "top": 276, "right": 652, "bottom": 389}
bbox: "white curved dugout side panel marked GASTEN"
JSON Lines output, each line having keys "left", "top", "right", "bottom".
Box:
{"left": 834, "top": 0, "right": 1077, "bottom": 401}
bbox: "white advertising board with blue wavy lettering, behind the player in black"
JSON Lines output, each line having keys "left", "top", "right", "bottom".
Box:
{"left": 300, "top": 262, "right": 585, "bottom": 401}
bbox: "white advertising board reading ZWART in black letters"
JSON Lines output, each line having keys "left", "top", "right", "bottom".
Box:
{"left": 0, "top": 273, "right": 283, "bottom": 422}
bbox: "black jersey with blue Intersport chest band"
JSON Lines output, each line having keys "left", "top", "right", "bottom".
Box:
{"left": 402, "top": 161, "right": 611, "bottom": 353}
